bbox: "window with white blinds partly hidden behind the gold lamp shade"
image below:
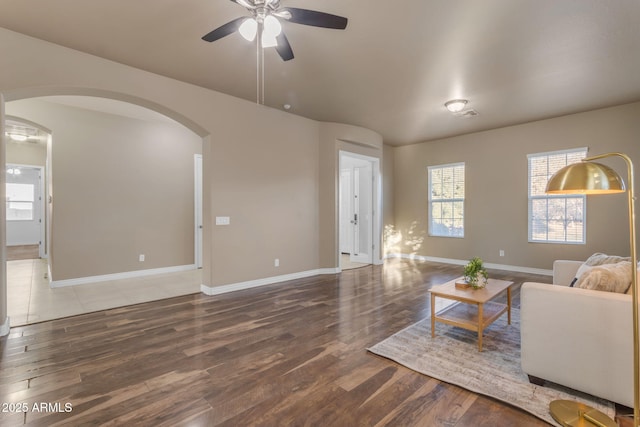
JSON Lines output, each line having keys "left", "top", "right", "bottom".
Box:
{"left": 528, "top": 148, "right": 587, "bottom": 243}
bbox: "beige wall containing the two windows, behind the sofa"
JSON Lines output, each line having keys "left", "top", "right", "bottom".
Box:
{"left": 387, "top": 103, "right": 640, "bottom": 269}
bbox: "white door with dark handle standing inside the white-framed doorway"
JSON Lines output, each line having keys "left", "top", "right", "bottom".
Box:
{"left": 351, "top": 160, "right": 373, "bottom": 264}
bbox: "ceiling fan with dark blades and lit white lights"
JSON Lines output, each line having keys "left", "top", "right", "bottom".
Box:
{"left": 202, "top": 0, "right": 347, "bottom": 61}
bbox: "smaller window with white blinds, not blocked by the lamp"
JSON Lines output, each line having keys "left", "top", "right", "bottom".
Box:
{"left": 428, "top": 163, "right": 464, "bottom": 237}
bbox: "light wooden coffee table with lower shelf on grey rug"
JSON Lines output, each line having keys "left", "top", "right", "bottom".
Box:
{"left": 429, "top": 277, "right": 513, "bottom": 351}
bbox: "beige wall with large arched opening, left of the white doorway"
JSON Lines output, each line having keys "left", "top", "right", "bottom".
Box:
{"left": 0, "top": 25, "right": 382, "bottom": 304}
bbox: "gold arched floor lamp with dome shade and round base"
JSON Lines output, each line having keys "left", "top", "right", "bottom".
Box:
{"left": 546, "top": 153, "right": 640, "bottom": 427}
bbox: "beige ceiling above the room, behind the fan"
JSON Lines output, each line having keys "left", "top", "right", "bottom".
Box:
{"left": 0, "top": 0, "right": 640, "bottom": 145}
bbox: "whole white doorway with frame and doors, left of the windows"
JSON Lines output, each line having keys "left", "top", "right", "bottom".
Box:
{"left": 338, "top": 151, "right": 380, "bottom": 270}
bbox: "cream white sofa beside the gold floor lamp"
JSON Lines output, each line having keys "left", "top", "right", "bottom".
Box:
{"left": 520, "top": 260, "right": 633, "bottom": 407}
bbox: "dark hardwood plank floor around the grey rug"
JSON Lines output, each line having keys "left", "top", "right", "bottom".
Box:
{"left": 0, "top": 260, "right": 596, "bottom": 427}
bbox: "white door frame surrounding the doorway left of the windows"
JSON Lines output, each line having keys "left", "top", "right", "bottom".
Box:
{"left": 337, "top": 150, "right": 382, "bottom": 269}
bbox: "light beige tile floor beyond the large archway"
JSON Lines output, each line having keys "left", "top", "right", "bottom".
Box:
{"left": 7, "top": 259, "right": 202, "bottom": 326}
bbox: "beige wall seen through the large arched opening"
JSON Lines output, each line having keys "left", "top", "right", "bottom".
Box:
{"left": 6, "top": 98, "right": 202, "bottom": 280}
